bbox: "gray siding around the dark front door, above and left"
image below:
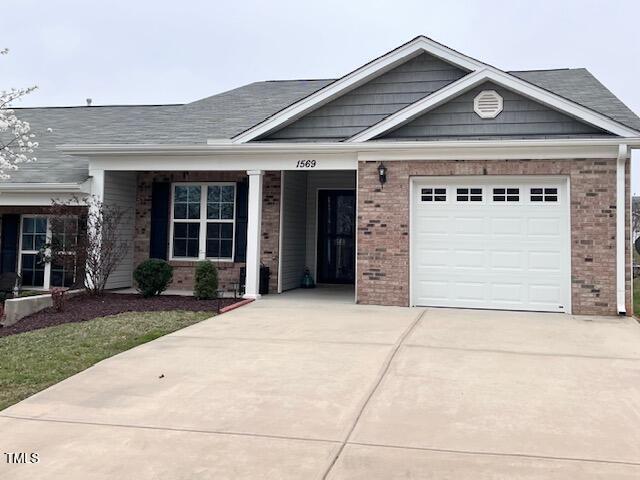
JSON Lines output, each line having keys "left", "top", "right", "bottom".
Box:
{"left": 306, "top": 170, "right": 356, "bottom": 278}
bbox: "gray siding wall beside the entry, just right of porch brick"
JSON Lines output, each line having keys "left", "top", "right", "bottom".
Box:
{"left": 280, "top": 171, "right": 307, "bottom": 292}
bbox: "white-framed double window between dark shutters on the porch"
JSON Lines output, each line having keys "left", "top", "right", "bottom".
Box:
{"left": 171, "top": 183, "right": 236, "bottom": 261}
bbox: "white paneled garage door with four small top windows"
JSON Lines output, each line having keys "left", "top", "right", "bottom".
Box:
{"left": 411, "top": 176, "right": 571, "bottom": 312}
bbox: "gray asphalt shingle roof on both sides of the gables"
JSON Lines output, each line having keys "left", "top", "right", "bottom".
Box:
{"left": 3, "top": 68, "right": 640, "bottom": 183}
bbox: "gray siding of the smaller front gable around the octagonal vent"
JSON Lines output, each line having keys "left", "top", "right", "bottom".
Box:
{"left": 379, "top": 82, "right": 606, "bottom": 140}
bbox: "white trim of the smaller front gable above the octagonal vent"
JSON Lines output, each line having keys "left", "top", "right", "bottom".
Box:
{"left": 346, "top": 67, "right": 640, "bottom": 143}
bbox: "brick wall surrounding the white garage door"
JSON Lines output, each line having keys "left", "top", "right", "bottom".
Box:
{"left": 357, "top": 159, "right": 631, "bottom": 315}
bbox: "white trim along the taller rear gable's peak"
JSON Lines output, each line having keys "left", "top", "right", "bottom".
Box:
{"left": 232, "top": 36, "right": 487, "bottom": 143}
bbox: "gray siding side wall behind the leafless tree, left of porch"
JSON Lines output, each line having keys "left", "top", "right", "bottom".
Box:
{"left": 104, "top": 172, "right": 137, "bottom": 288}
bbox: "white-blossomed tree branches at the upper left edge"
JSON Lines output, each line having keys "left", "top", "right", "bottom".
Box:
{"left": 0, "top": 49, "right": 38, "bottom": 180}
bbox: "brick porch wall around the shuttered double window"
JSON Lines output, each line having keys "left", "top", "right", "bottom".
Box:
{"left": 134, "top": 172, "right": 280, "bottom": 293}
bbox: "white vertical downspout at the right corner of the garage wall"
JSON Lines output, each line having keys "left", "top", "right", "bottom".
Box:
{"left": 616, "top": 144, "right": 629, "bottom": 315}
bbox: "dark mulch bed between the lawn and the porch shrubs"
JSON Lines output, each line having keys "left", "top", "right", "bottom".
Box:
{"left": 0, "top": 293, "right": 242, "bottom": 337}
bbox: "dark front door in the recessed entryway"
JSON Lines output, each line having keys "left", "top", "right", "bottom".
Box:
{"left": 317, "top": 190, "right": 356, "bottom": 283}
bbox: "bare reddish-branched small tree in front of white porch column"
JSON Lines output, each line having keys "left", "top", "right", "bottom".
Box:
{"left": 43, "top": 196, "right": 129, "bottom": 295}
